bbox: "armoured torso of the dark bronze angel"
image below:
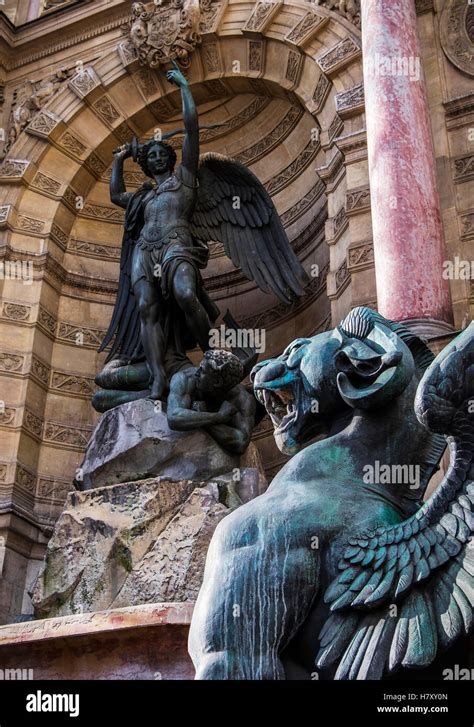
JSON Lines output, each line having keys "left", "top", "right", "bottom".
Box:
{"left": 140, "top": 169, "right": 197, "bottom": 242}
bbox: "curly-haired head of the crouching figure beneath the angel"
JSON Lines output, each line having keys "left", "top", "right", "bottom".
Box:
{"left": 196, "top": 349, "right": 244, "bottom": 398}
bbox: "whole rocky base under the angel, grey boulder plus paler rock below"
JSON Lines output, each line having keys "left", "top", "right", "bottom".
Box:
{"left": 30, "top": 400, "right": 267, "bottom": 618}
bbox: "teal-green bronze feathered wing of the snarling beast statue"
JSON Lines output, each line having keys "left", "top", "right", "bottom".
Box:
{"left": 316, "top": 323, "right": 474, "bottom": 679}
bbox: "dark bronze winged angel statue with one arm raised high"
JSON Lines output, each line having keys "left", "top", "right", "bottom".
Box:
{"left": 94, "top": 64, "right": 307, "bottom": 411}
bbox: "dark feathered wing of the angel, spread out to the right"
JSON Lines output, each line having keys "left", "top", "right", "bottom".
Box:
{"left": 191, "top": 153, "right": 308, "bottom": 303}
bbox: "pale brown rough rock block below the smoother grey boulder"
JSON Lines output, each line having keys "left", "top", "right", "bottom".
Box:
{"left": 31, "top": 468, "right": 264, "bottom": 618}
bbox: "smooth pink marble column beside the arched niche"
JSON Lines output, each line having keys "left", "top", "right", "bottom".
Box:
{"left": 361, "top": 0, "right": 452, "bottom": 335}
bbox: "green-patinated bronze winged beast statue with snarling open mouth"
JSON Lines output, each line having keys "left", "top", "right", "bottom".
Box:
{"left": 189, "top": 308, "right": 474, "bottom": 679}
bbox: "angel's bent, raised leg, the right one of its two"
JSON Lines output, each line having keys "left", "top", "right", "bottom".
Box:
{"left": 173, "top": 262, "right": 211, "bottom": 351}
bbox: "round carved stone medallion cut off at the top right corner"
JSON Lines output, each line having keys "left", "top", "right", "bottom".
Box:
{"left": 440, "top": 0, "right": 474, "bottom": 76}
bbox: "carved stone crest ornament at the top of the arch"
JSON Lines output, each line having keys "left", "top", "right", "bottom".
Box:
{"left": 126, "top": 0, "right": 201, "bottom": 68}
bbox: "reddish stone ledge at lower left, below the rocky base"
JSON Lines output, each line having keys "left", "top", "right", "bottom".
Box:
{"left": 0, "top": 602, "right": 194, "bottom": 680}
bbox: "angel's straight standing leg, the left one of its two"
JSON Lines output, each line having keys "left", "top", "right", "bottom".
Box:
{"left": 134, "top": 279, "right": 166, "bottom": 399}
